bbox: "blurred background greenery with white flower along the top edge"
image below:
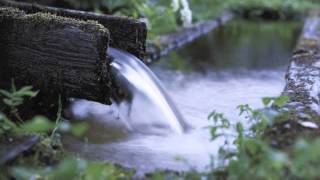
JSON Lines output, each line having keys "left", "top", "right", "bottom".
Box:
{"left": 28, "top": 0, "right": 320, "bottom": 39}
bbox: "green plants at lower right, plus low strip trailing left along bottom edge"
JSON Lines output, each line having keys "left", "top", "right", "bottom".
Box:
{"left": 150, "top": 96, "right": 320, "bottom": 180}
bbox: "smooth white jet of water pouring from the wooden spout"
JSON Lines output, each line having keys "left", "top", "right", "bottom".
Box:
{"left": 108, "top": 48, "right": 188, "bottom": 134}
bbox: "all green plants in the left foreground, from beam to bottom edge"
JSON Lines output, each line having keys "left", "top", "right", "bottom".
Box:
{"left": 0, "top": 83, "right": 133, "bottom": 180}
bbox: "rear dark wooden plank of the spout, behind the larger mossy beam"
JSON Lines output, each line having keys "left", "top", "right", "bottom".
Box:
{"left": 0, "top": 0, "right": 147, "bottom": 59}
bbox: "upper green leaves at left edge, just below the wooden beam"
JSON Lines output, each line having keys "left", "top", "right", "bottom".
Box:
{"left": 0, "top": 81, "right": 89, "bottom": 137}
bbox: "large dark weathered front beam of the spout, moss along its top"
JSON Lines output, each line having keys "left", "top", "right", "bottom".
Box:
{"left": 0, "top": 8, "right": 111, "bottom": 109}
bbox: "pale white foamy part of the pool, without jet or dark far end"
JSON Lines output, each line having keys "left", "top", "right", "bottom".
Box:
{"left": 66, "top": 70, "right": 284, "bottom": 173}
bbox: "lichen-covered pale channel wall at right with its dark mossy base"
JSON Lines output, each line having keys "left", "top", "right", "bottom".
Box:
{"left": 265, "top": 13, "right": 320, "bottom": 149}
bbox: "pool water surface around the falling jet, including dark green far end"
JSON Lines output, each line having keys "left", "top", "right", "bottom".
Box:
{"left": 64, "top": 20, "right": 301, "bottom": 173}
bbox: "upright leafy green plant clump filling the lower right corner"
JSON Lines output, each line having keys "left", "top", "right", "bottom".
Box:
{"left": 206, "top": 96, "right": 320, "bottom": 180}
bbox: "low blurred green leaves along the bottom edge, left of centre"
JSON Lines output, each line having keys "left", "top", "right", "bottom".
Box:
{"left": 10, "top": 157, "right": 133, "bottom": 180}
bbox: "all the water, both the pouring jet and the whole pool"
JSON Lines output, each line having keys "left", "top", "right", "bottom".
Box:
{"left": 64, "top": 20, "right": 301, "bottom": 174}
